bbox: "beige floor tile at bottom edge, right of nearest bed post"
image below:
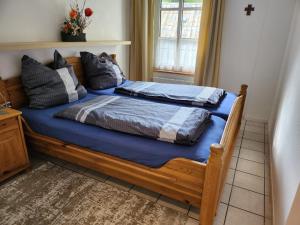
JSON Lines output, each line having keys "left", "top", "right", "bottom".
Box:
{"left": 225, "top": 206, "right": 264, "bottom": 225}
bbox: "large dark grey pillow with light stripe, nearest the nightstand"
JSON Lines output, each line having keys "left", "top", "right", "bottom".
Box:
{"left": 21, "top": 52, "right": 87, "bottom": 109}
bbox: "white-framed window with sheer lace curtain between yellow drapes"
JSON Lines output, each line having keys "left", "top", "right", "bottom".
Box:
{"left": 154, "top": 0, "right": 203, "bottom": 73}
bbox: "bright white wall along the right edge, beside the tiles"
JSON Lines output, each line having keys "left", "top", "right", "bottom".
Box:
{"left": 269, "top": 1, "right": 300, "bottom": 225}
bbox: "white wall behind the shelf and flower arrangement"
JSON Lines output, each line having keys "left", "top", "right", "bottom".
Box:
{"left": 0, "top": 0, "right": 130, "bottom": 79}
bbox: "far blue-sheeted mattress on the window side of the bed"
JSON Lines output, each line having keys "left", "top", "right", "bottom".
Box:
{"left": 88, "top": 80, "right": 237, "bottom": 120}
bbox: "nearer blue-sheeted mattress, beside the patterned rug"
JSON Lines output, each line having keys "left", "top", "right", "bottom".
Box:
{"left": 21, "top": 94, "right": 226, "bottom": 168}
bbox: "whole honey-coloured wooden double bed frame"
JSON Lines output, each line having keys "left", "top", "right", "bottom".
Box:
{"left": 0, "top": 55, "right": 248, "bottom": 225}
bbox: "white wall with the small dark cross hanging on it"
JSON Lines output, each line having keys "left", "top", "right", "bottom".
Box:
{"left": 220, "top": 0, "right": 295, "bottom": 121}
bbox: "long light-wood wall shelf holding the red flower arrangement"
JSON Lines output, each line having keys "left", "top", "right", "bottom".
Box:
{"left": 0, "top": 40, "right": 131, "bottom": 51}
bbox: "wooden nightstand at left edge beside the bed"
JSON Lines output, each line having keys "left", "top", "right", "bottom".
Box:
{"left": 0, "top": 108, "right": 30, "bottom": 182}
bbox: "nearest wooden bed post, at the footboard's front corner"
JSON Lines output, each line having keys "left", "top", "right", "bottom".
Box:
{"left": 200, "top": 144, "right": 224, "bottom": 225}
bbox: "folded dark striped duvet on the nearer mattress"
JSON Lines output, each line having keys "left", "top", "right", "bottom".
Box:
{"left": 55, "top": 95, "right": 210, "bottom": 145}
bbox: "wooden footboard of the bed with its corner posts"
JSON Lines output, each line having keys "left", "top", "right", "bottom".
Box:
{"left": 200, "top": 85, "right": 248, "bottom": 225}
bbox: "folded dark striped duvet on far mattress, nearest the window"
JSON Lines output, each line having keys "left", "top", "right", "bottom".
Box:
{"left": 115, "top": 81, "right": 225, "bottom": 106}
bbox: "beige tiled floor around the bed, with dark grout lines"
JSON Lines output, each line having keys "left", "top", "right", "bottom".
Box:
{"left": 29, "top": 118, "right": 272, "bottom": 225}
